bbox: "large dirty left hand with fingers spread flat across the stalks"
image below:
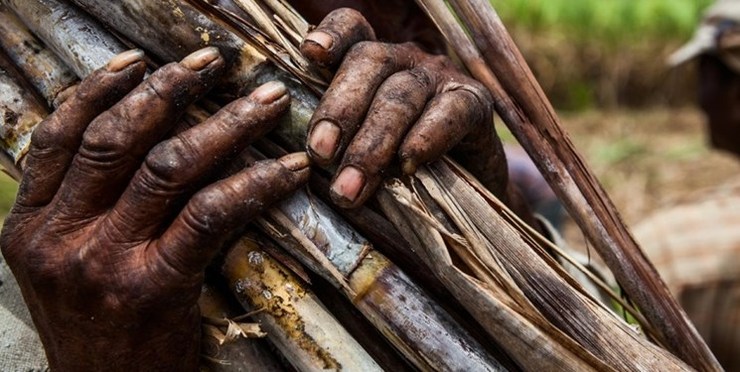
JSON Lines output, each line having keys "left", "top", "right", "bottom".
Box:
{"left": 1, "top": 48, "right": 309, "bottom": 371}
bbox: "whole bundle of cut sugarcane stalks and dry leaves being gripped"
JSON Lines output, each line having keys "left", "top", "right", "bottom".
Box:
{"left": 0, "top": 0, "right": 719, "bottom": 370}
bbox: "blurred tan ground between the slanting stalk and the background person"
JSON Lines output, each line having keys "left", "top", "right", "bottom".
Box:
{"left": 536, "top": 107, "right": 740, "bottom": 253}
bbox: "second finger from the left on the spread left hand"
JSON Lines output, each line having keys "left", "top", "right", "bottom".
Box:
{"left": 59, "top": 48, "right": 224, "bottom": 218}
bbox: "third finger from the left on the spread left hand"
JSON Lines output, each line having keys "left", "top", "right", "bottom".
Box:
{"left": 109, "top": 82, "right": 290, "bottom": 241}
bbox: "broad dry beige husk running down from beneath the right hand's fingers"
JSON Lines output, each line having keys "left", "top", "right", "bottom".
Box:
{"left": 381, "top": 158, "right": 689, "bottom": 370}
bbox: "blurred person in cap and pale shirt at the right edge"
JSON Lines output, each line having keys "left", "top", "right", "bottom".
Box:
{"left": 633, "top": 0, "right": 740, "bottom": 371}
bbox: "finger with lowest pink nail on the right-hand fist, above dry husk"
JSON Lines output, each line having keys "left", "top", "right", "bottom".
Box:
{"left": 331, "top": 68, "right": 436, "bottom": 207}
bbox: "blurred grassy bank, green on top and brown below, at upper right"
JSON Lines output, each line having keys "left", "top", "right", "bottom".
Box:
{"left": 490, "top": 0, "right": 713, "bottom": 110}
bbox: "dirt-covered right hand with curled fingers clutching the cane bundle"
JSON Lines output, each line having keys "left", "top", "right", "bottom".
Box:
{"left": 301, "top": 8, "right": 508, "bottom": 207}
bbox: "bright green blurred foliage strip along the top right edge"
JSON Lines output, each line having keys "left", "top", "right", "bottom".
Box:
{"left": 491, "top": 0, "right": 713, "bottom": 43}
